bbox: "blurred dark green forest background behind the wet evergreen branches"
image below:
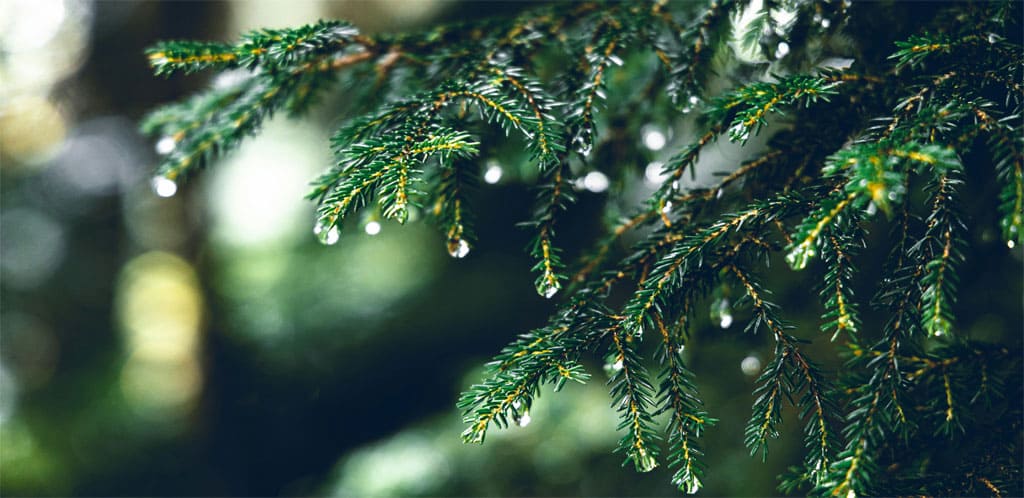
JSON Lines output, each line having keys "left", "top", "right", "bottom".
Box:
{"left": 0, "top": 0, "right": 1021, "bottom": 496}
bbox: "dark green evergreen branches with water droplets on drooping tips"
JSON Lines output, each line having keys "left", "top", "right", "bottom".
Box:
{"left": 142, "top": 0, "right": 1024, "bottom": 496}
